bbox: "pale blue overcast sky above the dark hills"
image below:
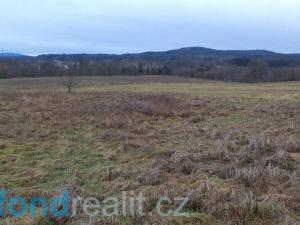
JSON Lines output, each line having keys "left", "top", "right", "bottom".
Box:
{"left": 0, "top": 0, "right": 300, "bottom": 55}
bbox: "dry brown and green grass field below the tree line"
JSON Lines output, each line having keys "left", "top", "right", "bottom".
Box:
{"left": 0, "top": 76, "right": 300, "bottom": 225}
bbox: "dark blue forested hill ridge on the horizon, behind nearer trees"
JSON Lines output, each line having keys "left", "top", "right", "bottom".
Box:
{"left": 35, "top": 47, "right": 300, "bottom": 66}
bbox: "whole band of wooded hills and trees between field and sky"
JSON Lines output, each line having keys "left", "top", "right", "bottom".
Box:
{"left": 0, "top": 47, "right": 300, "bottom": 82}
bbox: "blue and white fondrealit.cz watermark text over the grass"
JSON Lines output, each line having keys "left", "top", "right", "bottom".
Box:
{"left": 0, "top": 190, "right": 189, "bottom": 219}
